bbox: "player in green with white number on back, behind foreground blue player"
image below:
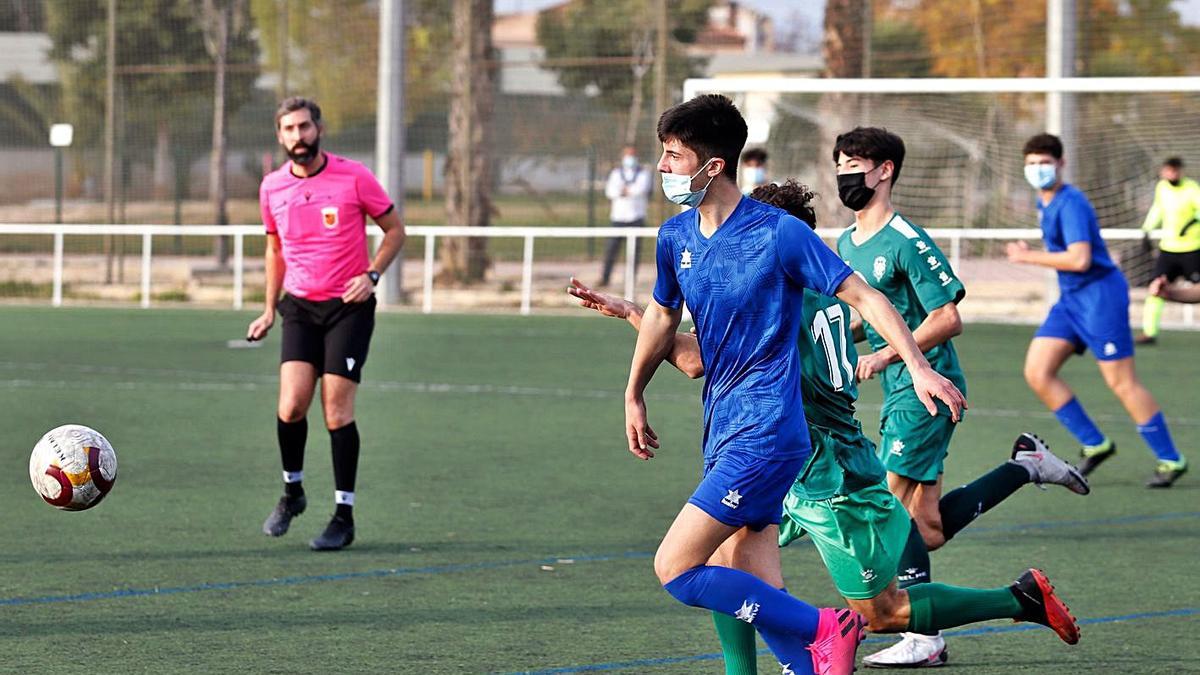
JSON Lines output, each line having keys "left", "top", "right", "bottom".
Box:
{"left": 568, "top": 181, "right": 1079, "bottom": 675}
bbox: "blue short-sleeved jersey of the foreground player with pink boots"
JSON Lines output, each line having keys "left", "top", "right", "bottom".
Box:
{"left": 654, "top": 198, "right": 852, "bottom": 461}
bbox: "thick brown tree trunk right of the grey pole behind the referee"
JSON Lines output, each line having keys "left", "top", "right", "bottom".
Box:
{"left": 440, "top": 0, "right": 496, "bottom": 283}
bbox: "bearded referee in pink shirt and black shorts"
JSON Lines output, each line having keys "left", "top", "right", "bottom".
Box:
{"left": 246, "top": 97, "right": 404, "bottom": 550}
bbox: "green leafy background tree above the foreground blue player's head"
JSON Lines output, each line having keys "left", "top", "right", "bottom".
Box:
{"left": 538, "top": 0, "right": 712, "bottom": 143}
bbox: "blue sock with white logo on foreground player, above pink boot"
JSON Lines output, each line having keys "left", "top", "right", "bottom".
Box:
{"left": 662, "top": 565, "right": 821, "bottom": 673}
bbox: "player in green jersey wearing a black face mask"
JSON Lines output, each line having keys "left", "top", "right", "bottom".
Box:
{"left": 833, "top": 127, "right": 1088, "bottom": 667}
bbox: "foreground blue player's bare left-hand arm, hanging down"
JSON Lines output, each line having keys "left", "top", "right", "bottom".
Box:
{"left": 625, "top": 300, "right": 683, "bottom": 459}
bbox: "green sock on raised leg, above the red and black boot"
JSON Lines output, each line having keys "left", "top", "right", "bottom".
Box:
{"left": 908, "top": 584, "right": 1021, "bottom": 634}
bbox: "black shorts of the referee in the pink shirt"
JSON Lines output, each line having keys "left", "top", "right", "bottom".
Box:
{"left": 278, "top": 295, "right": 376, "bottom": 382}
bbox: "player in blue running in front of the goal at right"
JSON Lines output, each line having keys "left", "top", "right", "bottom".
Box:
{"left": 1008, "top": 133, "right": 1187, "bottom": 488}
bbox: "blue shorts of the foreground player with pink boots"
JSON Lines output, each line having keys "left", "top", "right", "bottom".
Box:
{"left": 688, "top": 450, "right": 808, "bottom": 532}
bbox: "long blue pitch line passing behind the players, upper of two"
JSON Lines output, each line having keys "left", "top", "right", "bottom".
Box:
{"left": 0, "top": 510, "right": 1200, "bottom": 607}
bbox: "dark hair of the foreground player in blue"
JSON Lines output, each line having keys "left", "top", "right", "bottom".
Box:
{"left": 658, "top": 94, "right": 746, "bottom": 180}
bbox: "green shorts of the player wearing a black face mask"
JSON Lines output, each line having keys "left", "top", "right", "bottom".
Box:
{"left": 878, "top": 410, "right": 956, "bottom": 484}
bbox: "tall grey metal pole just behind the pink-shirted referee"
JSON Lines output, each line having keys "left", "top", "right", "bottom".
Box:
{"left": 376, "top": 0, "right": 404, "bottom": 303}
